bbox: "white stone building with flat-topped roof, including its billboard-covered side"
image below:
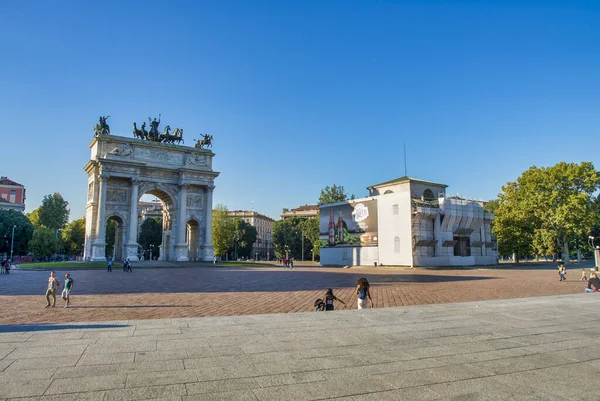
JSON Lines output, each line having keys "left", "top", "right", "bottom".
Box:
{"left": 320, "top": 177, "right": 498, "bottom": 267}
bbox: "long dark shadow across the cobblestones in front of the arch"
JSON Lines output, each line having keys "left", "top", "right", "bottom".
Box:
{"left": 0, "top": 268, "right": 498, "bottom": 300}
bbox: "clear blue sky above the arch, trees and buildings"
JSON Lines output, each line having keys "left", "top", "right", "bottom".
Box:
{"left": 0, "top": 0, "right": 600, "bottom": 218}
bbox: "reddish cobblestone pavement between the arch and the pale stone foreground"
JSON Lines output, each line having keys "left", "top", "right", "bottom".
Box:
{"left": 0, "top": 267, "right": 585, "bottom": 324}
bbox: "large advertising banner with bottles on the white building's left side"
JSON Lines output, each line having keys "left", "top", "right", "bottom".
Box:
{"left": 319, "top": 200, "right": 377, "bottom": 248}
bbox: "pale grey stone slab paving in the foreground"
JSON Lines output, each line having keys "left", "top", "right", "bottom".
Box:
{"left": 0, "top": 294, "right": 600, "bottom": 401}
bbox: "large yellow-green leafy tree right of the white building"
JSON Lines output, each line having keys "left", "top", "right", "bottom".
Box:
{"left": 494, "top": 162, "right": 600, "bottom": 260}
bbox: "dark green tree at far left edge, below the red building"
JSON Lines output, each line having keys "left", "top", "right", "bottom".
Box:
{"left": 0, "top": 209, "right": 34, "bottom": 255}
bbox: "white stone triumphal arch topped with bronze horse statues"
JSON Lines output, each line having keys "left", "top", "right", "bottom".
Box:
{"left": 84, "top": 117, "right": 219, "bottom": 261}
